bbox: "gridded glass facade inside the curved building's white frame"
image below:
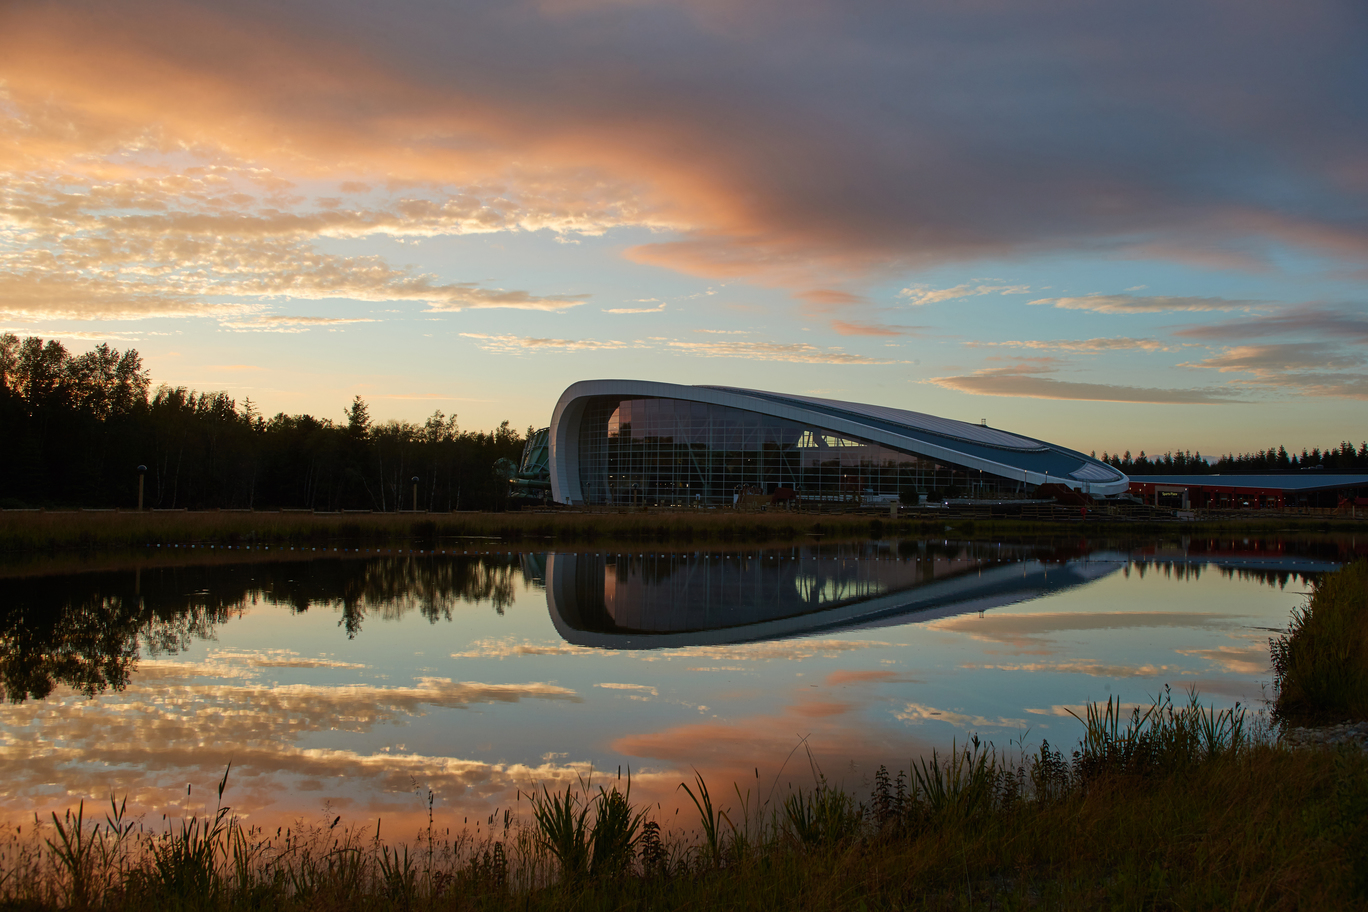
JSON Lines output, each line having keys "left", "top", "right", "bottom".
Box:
{"left": 579, "top": 397, "right": 1023, "bottom": 506}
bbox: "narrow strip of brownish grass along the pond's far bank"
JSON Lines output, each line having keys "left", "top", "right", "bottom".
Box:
{"left": 0, "top": 509, "right": 1360, "bottom": 554}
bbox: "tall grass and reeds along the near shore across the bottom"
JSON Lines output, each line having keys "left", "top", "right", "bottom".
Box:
{"left": 8, "top": 693, "right": 1368, "bottom": 911}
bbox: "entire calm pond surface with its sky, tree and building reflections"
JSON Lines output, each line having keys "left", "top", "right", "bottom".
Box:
{"left": 0, "top": 539, "right": 1357, "bottom": 833}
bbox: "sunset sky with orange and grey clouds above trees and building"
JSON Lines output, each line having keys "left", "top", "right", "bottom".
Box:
{"left": 0, "top": 0, "right": 1368, "bottom": 455}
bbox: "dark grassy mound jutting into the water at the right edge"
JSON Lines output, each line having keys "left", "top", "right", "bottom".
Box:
{"left": 1270, "top": 561, "right": 1368, "bottom": 723}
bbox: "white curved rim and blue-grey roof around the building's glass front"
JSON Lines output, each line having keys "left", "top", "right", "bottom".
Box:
{"left": 550, "top": 380, "right": 1129, "bottom": 503}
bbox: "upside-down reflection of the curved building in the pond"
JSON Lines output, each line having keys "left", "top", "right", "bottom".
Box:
{"left": 546, "top": 541, "right": 1129, "bottom": 649}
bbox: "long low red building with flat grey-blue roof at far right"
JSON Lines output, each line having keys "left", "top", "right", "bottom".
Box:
{"left": 1130, "top": 470, "right": 1368, "bottom": 510}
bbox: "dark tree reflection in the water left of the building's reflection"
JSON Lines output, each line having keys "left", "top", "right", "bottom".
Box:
{"left": 0, "top": 555, "right": 544, "bottom": 703}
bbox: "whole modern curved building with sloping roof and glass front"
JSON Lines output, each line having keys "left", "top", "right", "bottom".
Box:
{"left": 550, "top": 380, "right": 1129, "bottom": 506}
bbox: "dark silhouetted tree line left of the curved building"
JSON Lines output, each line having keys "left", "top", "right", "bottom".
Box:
{"left": 0, "top": 334, "right": 531, "bottom": 511}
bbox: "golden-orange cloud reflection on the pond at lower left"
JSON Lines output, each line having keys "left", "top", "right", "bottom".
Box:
{"left": 0, "top": 651, "right": 581, "bottom": 825}
